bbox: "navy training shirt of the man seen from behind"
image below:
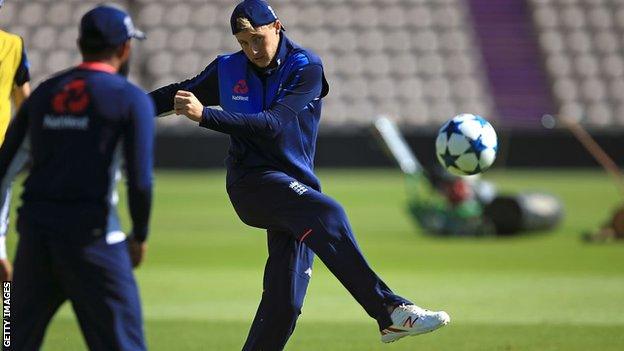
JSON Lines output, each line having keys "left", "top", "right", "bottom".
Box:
{"left": 0, "top": 62, "right": 155, "bottom": 241}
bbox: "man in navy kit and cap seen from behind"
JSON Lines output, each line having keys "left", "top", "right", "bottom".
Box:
{"left": 0, "top": 6, "right": 154, "bottom": 351}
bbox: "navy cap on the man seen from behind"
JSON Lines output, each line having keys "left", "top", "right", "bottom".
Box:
{"left": 80, "top": 5, "right": 145, "bottom": 46}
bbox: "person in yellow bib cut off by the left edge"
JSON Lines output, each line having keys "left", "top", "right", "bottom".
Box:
{"left": 0, "top": 0, "right": 30, "bottom": 281}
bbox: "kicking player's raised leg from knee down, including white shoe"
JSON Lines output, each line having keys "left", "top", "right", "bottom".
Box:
{"left": 282, "top": 189, "right": 450, "bottom": 342}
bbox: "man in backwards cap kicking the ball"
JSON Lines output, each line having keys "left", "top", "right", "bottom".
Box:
{"left": 151, "top": 0, "right": 450, "bottom": 351}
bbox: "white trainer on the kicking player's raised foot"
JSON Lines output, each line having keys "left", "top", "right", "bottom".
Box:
{"left": 381, "top": 305, "right": 451, "bottom": 343}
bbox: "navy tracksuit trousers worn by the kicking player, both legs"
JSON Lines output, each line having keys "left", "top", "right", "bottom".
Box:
{"left": 228, "top": 171, "right": 411, "bottom": 351}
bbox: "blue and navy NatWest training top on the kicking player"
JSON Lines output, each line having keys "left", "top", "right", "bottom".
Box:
{"left": 150, "top": 33, "right": 329, "bottom": 189}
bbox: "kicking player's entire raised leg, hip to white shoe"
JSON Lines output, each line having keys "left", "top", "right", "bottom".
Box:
{"left": 228, "top": 172, "right": 450, "bottom": 342}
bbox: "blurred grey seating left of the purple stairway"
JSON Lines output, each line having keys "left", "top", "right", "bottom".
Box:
{"left": 0, "top": 0, "right": 495, "bottom": 129}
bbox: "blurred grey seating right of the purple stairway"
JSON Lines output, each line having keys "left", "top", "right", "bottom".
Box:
{"left": 530, "top": 0, "right": 624, "bottom": 128}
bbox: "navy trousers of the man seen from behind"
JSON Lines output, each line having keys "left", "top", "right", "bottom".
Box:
{"left": 7, "top": 220, "right": 146, "bottom": 351}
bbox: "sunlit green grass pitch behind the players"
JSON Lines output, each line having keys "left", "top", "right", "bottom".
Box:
{"left": 4, "top": 170, "right": 624, "bottom": 351}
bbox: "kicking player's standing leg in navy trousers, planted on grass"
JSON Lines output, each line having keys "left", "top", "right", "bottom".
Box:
{"left": 243, "top": 230, "right": 314, "bottom": 351}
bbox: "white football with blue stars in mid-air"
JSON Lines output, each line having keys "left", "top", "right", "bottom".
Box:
{"left": 436, "top": 113, "right": 498, "bottom": 175}
